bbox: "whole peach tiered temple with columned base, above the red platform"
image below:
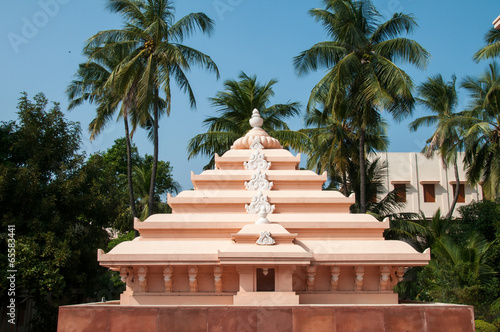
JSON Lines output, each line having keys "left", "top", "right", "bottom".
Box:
{"left": 98, "top": 110, "right": 430, "bottom": 305}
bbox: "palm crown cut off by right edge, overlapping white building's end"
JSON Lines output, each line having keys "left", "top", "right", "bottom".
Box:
{"left": 459, "top": 63, "right": 500, "bottom": 200}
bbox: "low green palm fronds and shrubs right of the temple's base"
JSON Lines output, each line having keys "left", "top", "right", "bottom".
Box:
{"left": 391, "top": 201, "right": 500, "bottom": 322}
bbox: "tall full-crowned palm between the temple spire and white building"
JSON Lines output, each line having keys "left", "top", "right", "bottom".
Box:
{"left": 294, "top": 0, "right": 429, "bottom": 213}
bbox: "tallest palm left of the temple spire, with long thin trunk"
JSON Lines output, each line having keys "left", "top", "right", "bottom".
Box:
{"left": 85, "top": 0, "right": 219, "bottom": 215}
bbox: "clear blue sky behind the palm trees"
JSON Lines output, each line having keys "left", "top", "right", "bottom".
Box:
{"left": 0, "top": 0, "right": 500, "bottom": 189}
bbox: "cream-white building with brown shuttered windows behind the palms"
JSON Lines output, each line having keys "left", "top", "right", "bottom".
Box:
{"left": 370, "top": 152, "right": 483, "bottom": 218}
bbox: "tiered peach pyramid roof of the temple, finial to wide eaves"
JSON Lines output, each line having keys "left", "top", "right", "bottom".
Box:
{"left": 99, "top": 111, "right": 430, "bottom": 269}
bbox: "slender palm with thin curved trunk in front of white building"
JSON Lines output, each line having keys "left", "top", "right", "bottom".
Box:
{"left": 409, "top": 75, "right": 461, "bottom": 219}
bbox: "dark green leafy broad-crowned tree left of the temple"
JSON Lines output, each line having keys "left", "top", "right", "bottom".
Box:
{"left": 0, "top": 93, "right": 125, "bottom": 331}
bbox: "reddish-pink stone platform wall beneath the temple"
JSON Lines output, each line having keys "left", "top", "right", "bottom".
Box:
{"left": 58, "top": 304, "right": 475, "bottom": 332}
